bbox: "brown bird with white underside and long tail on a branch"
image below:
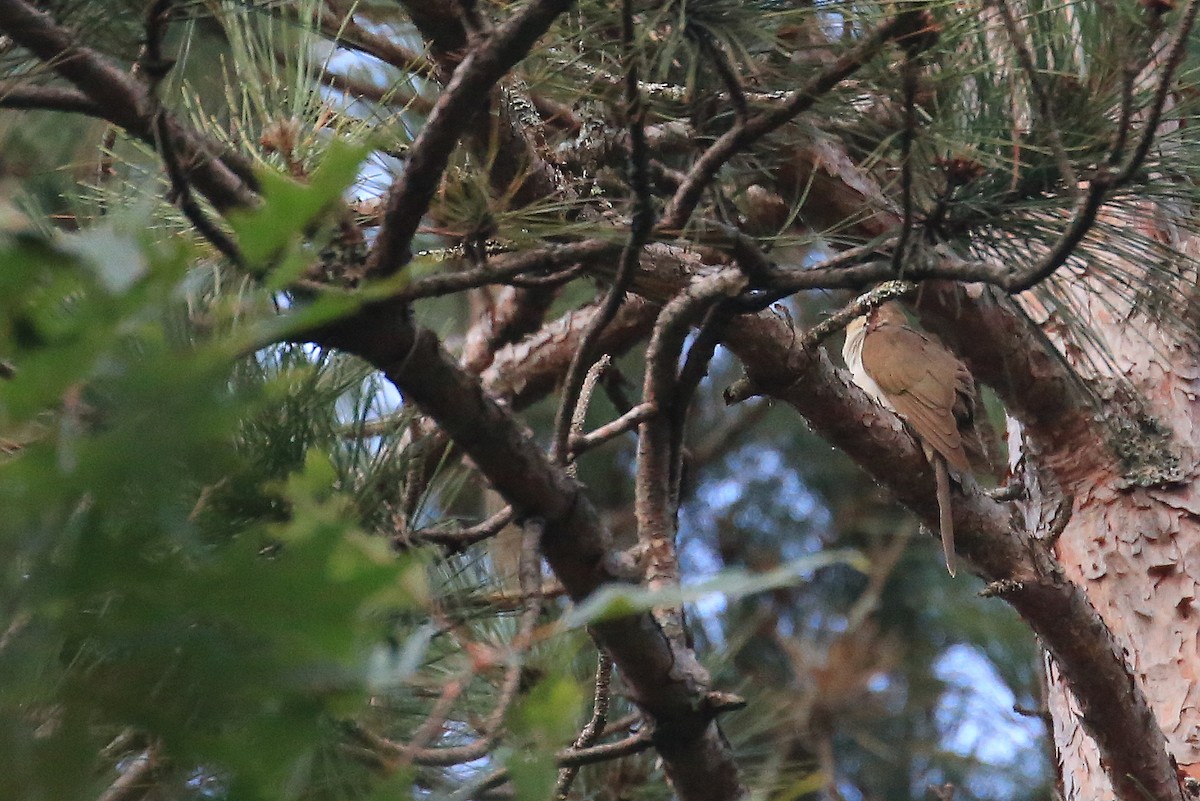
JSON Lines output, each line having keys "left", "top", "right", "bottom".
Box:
{"left": 842, "top": 301, "right": 982, "bottom": 576}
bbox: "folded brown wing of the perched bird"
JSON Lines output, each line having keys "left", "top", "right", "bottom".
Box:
{"left": 863, "top": 324, "right": 971, "bottom": 472}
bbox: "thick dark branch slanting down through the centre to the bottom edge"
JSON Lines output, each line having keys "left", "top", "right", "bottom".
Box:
{"left": 314, "top": 303, "right": 743, "bottom": 801}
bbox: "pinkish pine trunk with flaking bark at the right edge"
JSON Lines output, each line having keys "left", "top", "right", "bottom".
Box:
{"left": 1026, "top": 270, "right": 1200, "bottom": 801}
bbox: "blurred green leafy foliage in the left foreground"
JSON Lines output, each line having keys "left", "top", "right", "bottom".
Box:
{"left": 0, "top": 208, "right": 424, "bottom": 801}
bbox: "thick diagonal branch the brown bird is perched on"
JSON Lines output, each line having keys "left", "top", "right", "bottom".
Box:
{"left": 726, "top": 314, "right": 1182, "bottom": 801}
